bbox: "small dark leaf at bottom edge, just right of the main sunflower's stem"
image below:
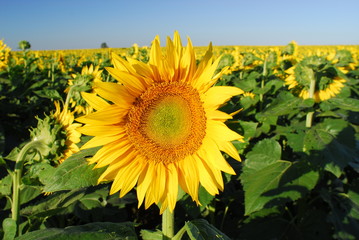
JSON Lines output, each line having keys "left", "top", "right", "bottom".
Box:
{"left": 185, "top": 219, "right": 230, "bottom": 240}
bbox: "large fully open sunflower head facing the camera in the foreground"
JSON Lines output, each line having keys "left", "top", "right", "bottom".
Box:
{"left": 77, "top": 32, "right": 243, "bottom": 213}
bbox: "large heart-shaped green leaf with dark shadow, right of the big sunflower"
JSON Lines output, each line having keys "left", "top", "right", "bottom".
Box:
{"left": 241, "top": 139, "right": 319, "bottom": 215}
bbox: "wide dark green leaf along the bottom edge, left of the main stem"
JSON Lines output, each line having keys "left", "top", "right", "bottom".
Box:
{"left": 16, "top": 222, "right": 137, "bottom": 240}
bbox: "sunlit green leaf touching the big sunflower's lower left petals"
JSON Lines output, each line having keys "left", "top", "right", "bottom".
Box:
{"left": 43, "top": 148, "right": 105, "bottom": 192}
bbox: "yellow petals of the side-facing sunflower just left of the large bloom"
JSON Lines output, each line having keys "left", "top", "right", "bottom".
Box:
{"left": 53, "top": 102, "right": 81, "bottom": 163}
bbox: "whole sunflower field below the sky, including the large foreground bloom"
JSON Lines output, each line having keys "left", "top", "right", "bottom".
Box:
{"left": 0, "top": 32, "right": 359, "bottom": 240}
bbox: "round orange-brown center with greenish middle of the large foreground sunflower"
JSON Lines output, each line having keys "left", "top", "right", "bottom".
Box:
{"left": 126, "top": 82, "right": 206, "bottom": 163}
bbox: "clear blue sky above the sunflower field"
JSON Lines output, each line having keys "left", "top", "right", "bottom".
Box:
{"left": 0, "top": 0, "right": 359, "bottom": 50}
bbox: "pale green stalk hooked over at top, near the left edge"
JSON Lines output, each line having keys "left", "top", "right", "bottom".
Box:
{"left": 11, "top": 140, "right": 42, "bottom": 234}
